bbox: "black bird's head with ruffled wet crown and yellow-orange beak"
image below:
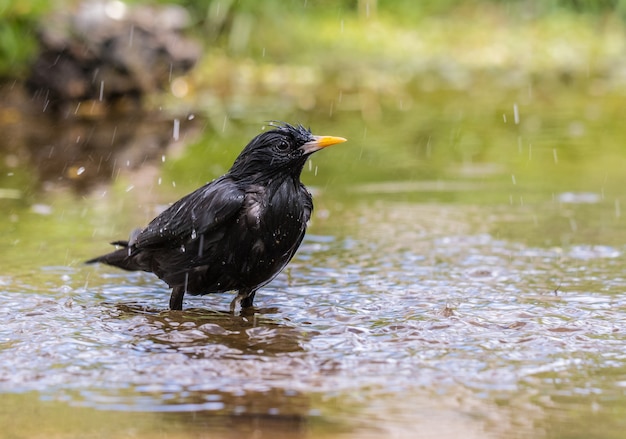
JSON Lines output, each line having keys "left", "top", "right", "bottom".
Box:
{"left": 229, "top": 122, "right": 346, "bottom": 178}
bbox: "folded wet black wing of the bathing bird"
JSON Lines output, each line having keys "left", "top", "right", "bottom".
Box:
{"left": 129, "top": 177, "right": 244, "bottom": 250}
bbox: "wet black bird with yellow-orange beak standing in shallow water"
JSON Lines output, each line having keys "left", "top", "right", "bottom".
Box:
{"left": 87, "top": 123, "right": 346, "bottom": 311}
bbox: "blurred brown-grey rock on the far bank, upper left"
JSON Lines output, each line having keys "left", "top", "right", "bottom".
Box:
{"left": 28, "top": 0, "right": 201, "bottom": 109}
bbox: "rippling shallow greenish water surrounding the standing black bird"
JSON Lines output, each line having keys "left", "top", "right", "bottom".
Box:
{"left": 0, "top": 55, "right": 626, "bottom": 438}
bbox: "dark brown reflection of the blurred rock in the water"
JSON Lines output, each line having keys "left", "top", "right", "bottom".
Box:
{"left": 0, "top": 89, "right": 197, "bottom": 193}
